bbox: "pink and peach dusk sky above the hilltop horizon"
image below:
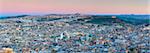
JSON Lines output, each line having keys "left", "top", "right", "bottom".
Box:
{"left": 0, "top": 0, "right": 150, "bottom": 14}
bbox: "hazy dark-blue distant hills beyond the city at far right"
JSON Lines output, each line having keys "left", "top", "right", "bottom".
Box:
{"left": 117, "top": 15, "right": 150, "bottom": 25}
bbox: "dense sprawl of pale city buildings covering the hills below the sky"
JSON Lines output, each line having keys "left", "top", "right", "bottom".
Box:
{"left": 0, "top": 13, "right": 150, "bottom": 53}
